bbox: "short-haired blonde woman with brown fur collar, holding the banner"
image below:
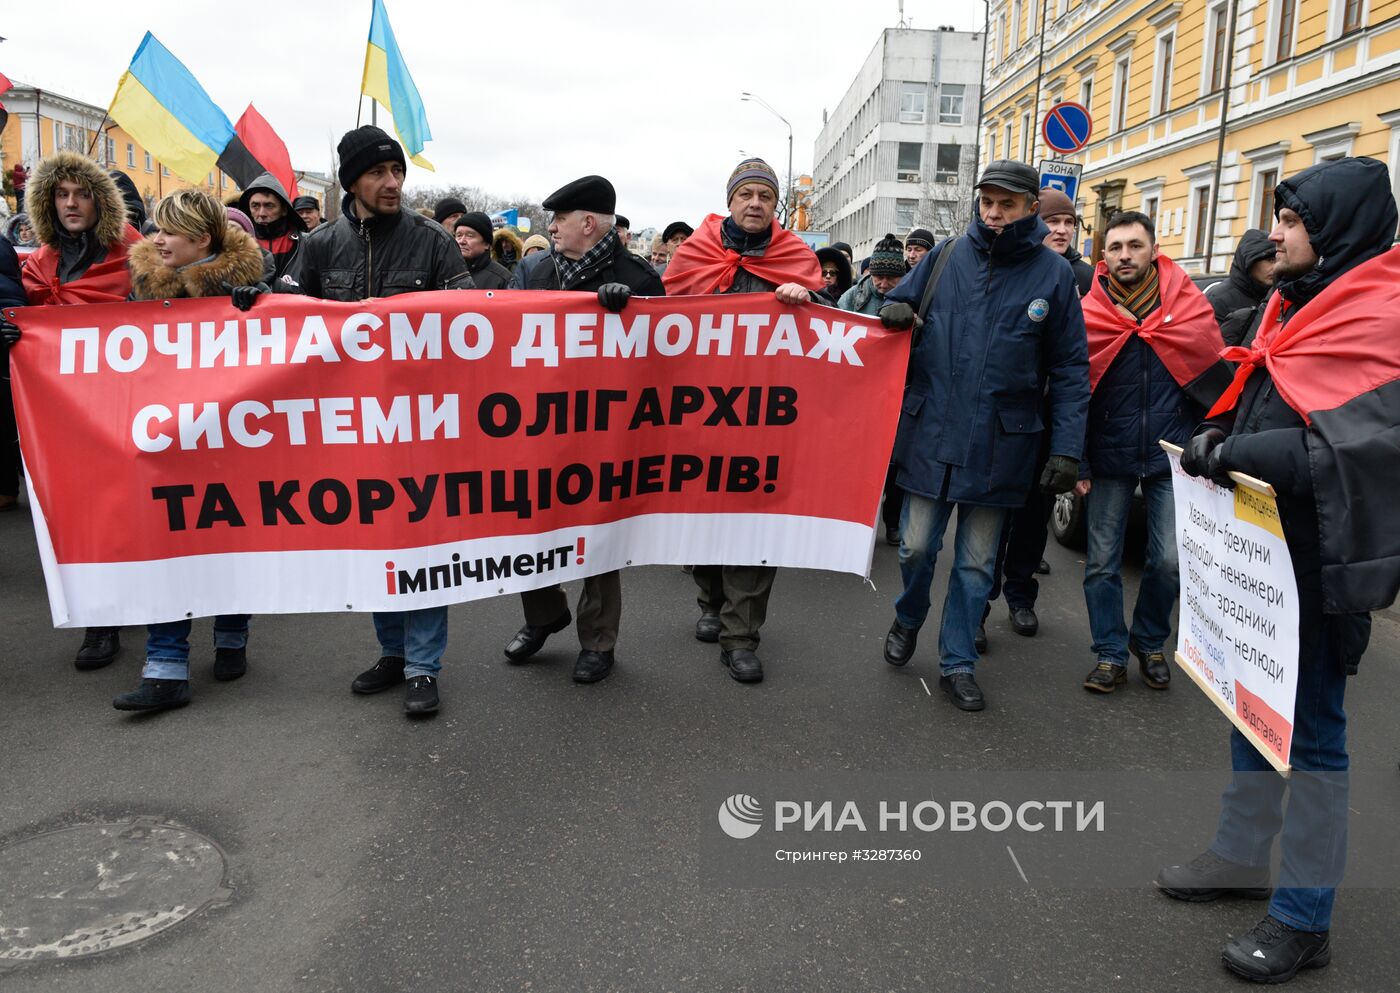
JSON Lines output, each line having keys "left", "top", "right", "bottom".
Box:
{"left": 112, "top": 189, "right": 263, "bottom": 710}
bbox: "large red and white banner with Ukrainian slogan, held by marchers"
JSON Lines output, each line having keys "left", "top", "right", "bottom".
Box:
{"left": 10, "top": 291, "right": 909, "bottom": 626}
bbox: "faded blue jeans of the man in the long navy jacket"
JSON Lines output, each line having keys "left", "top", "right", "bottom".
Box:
{"left": 895, "top": 493, "right": 1007, "bottom": 675}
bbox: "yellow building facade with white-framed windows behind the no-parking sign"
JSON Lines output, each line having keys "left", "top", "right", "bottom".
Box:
{"left": 980, "top": 0, "right": 1400, "bottom": 272}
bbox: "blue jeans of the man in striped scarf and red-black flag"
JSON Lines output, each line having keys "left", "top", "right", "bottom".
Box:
{"left": 1084, "top": 476, "right": 1180, "bottom": 665}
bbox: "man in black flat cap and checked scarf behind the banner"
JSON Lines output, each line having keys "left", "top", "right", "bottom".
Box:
{"left": 505, "top": 176, "right": 666, "bottom": 682}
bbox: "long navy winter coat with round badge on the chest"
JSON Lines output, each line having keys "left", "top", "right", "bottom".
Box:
{"left": 886, "top": 208, "right": 1089, "bottom": 507}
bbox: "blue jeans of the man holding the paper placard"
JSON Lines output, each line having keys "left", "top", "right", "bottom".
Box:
{"left": 1211, "top": 594, "right": 1350, "bottom": 931}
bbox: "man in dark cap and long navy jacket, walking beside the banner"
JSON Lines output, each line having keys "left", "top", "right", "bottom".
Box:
{"left": 879, "top": 160, "right": 1089, "bottom": 710}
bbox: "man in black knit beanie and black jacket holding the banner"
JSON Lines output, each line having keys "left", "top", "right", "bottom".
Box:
{"left": 277, "top": 125, "right": 472, "bottom": 714}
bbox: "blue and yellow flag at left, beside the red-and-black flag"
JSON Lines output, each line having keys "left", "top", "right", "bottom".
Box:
{"left": 108, "top": 31, "right": 235, "bottom": 182}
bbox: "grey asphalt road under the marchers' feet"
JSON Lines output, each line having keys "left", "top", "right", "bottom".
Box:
{"left": 0, "top": 495, "right": 1400, "bottom": 993}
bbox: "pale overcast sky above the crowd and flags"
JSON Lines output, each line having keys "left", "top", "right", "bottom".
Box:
{"left": 0, "top": 0, "right": 983, "bottom": 230}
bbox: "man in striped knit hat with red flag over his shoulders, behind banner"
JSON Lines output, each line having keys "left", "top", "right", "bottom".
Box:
{"left": 665, "top": 158, "right": 823, "bottom": 682}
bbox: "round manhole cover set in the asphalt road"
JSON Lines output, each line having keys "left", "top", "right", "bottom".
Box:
{"left": 0, "top": 818, "right": 230, "bottom": 968}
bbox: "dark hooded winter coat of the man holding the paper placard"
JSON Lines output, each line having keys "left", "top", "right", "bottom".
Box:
{"left": 1198, "top": 158, "right": 1400, "bottom": 610}
